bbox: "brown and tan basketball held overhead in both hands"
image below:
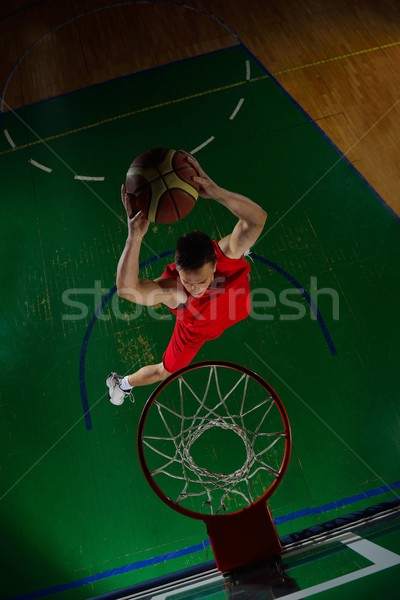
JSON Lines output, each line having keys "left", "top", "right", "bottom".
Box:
{"left": 125, "top": 148, "right": 200, "bottom": 223}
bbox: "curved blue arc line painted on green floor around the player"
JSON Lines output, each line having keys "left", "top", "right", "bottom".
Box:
{"left": 79, "top": 250, "right": 337, "bottom": 431}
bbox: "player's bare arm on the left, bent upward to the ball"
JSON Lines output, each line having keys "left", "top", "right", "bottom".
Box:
{"left": 117, "top": 187, "right": 180, "bottom": 308}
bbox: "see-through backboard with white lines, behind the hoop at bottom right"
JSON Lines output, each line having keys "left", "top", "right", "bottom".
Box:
{"left": 108, "top": 511, "right": 400, "bottom": 600}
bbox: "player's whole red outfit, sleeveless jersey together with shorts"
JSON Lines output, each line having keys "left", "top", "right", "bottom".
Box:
{"left": 162, "top": 240, "right": 251, "bottom": 373}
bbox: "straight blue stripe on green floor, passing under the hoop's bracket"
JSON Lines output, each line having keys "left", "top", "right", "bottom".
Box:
{"left": 7, "top": 481, "right": 400, "bottom": 600}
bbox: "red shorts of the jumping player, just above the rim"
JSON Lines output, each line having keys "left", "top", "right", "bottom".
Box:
{"left": 163, "top": 319, "right": 223, "bottom": 373}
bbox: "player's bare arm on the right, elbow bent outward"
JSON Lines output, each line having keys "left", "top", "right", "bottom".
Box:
{"left": 188, "top": 155, "right": 267, "bottom": 258}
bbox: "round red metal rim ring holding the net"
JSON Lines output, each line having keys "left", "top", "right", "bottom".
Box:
{"left": 137, "top": 360, "right": 292, "bottom": 523}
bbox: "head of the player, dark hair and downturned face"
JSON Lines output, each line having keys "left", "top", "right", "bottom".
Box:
{"left": 175, "top": 231, "right": 217, "bottom": 298}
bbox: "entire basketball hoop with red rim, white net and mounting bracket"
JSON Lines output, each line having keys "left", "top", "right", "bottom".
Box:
{"left": 138, "top": 361, "right": 291, "bottom": 573}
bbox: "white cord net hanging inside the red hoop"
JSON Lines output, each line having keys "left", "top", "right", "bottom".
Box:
{"left": 142, "top": 365, "right": 287, "bottom": 514}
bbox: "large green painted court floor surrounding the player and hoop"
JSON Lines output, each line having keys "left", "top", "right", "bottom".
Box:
{"left": 0, "top": 46, "right": 400, "bottom": 600}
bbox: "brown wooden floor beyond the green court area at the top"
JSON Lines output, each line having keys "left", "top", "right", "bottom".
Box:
{"left": 0, "top": 0, "right": 400, "bottom": 214}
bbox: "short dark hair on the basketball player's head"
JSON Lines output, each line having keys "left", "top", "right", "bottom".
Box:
{"left": 175, "top": 231, "right": 217, "bottom": 271}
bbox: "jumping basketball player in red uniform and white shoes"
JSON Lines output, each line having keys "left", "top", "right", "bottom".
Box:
{"left": 106, "top": 154, "right": 267, "bottom": 405}
